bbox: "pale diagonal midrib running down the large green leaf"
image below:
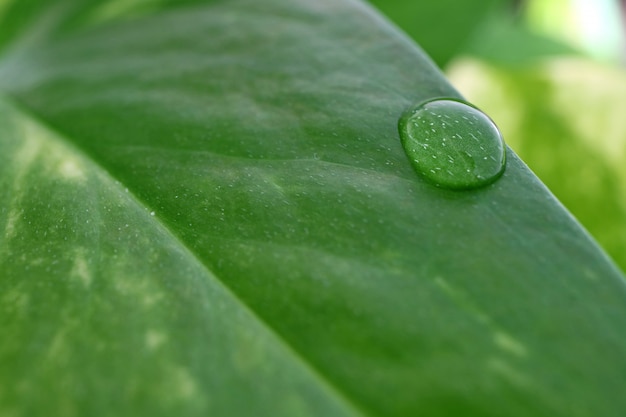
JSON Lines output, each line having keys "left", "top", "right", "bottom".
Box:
{"left": 0, "top": 91, "right": 375, "bottom": 417}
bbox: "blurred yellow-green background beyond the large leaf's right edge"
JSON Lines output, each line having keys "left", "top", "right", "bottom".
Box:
{"left": 371, "top": 0, "right": 626, "bottom": 271}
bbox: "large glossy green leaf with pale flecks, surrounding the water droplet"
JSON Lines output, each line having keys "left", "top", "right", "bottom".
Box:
{"left": 0, "top": 0, "right": 626, "bottom": 417}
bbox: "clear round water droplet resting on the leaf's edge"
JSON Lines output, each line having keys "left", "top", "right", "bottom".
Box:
{"left": 398, "top": 98, "right": 505, "bottom": 190}
